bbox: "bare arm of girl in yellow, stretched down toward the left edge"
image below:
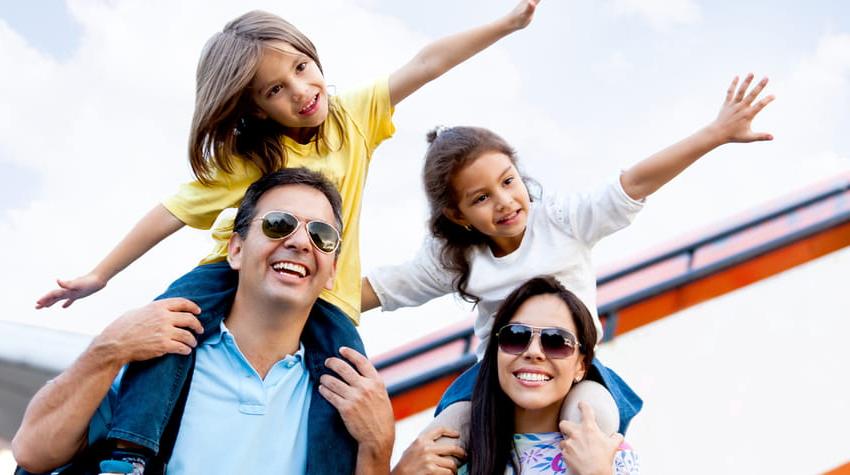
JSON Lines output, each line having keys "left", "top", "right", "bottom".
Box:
{"left": 35, "top": 205, "right": 183, "bottom": 308}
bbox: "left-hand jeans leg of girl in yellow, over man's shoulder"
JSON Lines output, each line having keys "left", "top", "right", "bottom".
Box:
{"left": 108, "top": 262, "right": 237, "bottom": 453}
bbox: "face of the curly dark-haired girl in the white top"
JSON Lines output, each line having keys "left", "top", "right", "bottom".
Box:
{"left": 444, "top": 152, "right": 531, "bottom": 257}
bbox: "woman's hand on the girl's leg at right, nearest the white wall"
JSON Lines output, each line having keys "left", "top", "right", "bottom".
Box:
{"left": 559, "top": 402, "right": 623, "bottom": 475}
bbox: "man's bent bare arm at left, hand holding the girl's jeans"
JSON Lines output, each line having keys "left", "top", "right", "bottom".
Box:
{"left": 12, "top": 299, "right": 204, "bottom": 473}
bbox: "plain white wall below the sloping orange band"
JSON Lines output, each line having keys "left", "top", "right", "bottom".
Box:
{"left": 395, "top": 249, "right": 850, "bottom": 475}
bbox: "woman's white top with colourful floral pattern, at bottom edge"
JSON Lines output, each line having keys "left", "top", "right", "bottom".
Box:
{"left": 458, "top": 432, "right": 640, "bottom": 475}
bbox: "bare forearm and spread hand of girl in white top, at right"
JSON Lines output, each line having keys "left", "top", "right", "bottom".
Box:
{"left": 620, "top": 74, "right": 774, "bottom": 200}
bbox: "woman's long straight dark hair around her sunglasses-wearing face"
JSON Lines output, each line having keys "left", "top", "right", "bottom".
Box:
{"left": 467, "top": 277, "right": 596, "bottom": 475}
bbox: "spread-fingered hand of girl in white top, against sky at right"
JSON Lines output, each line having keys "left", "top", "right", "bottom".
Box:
{"left": 711, "top": 73, "right": 774, "bottom": 143}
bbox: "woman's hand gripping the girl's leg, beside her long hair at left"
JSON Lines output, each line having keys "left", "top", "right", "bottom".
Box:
{"left": 392, "top": 427, "right": 466, "bottom": 475}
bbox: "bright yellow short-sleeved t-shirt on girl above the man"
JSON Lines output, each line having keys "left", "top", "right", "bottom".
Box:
{"left": 163, "top": 78, "right": 395, "bottom": 324}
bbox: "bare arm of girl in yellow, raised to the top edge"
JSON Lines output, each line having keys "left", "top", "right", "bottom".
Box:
{"left": 390, "top": 0, "right": 540, "bottom": 106}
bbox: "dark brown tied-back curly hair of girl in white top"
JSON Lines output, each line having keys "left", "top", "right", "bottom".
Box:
{"left": 422, "top": 127, "right": 527, "bottom": 303}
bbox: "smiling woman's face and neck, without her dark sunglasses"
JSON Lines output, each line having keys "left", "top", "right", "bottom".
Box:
{"left": 497, "top": 294, "right": 585, "bottom": 432}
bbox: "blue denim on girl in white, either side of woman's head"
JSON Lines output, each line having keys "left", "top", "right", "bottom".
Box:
{"left": 434, "top": 358, "right": 643, "bottom": 435}
